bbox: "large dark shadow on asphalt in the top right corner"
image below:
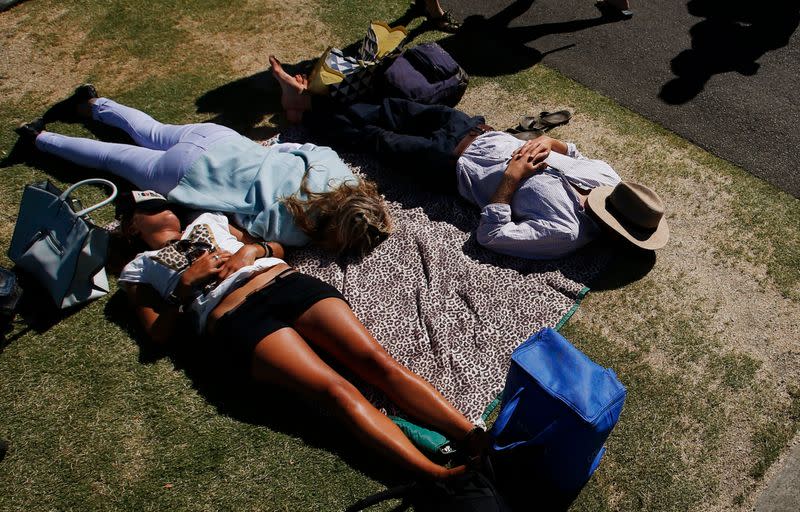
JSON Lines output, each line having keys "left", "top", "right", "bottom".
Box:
{"left": 659, "top": 0, "right": 800, "bottom": 105}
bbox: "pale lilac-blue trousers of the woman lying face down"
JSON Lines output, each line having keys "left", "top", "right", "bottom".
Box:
{"left": 36, "top": 98, "right": 241, "bottom": 196}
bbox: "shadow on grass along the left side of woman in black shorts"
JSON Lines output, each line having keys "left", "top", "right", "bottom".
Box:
{"left": 104, "top": 291, "right": 434, "bottom": 486}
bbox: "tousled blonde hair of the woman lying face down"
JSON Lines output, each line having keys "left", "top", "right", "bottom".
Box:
{"left": 283, "top": 174, "right": 392, "bottom": 256}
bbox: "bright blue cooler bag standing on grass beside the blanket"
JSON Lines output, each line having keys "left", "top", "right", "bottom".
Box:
{"left": 490, "top": 328, "right": 626, "bottom": 510}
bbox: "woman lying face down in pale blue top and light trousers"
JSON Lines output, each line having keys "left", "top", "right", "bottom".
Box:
{"left": 20, "top": 84, "right": 391, "bottom": 260}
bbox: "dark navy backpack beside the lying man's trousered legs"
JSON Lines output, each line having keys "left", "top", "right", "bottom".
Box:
{"left": 383, "top": 43, "right": 469, "bottom": 107}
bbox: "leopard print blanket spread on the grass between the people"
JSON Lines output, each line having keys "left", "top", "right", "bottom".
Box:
{"left": 265, "top": 133, "right": 605, "bottom": 425}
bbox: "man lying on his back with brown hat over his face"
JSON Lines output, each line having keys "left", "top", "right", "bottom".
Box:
{"left": 270, "top": 56, "right": 669, "bottom": 259}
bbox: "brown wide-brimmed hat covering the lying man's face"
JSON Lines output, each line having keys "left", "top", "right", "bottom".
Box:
{"left": 587, "top": 181, "right": 669, "bottom": 250}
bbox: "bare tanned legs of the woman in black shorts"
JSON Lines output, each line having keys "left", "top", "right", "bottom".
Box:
{"left": 252, "top": 298, "right": 473, "bottom": 478}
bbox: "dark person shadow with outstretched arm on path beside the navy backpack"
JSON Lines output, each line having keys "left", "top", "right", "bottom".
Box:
{"left": 437, "top": 0, "right": 619, "bottom": 76}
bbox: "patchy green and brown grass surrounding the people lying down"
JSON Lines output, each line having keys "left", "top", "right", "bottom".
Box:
{"left": 0, "top": 0, "right": 800, "bottom": 511}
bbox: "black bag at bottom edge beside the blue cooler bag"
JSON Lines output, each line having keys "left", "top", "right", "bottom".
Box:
{"left": 345, "top": 471, "right": 511, "bottom": 512}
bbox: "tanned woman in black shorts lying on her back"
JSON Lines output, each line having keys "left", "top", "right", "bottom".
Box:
{"left": 114, "top": 192, "right": 484, "bottom": 478}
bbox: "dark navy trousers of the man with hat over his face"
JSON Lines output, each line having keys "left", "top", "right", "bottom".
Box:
{"left": 303, "top": 97, "right": 485, "bottom": 187}
